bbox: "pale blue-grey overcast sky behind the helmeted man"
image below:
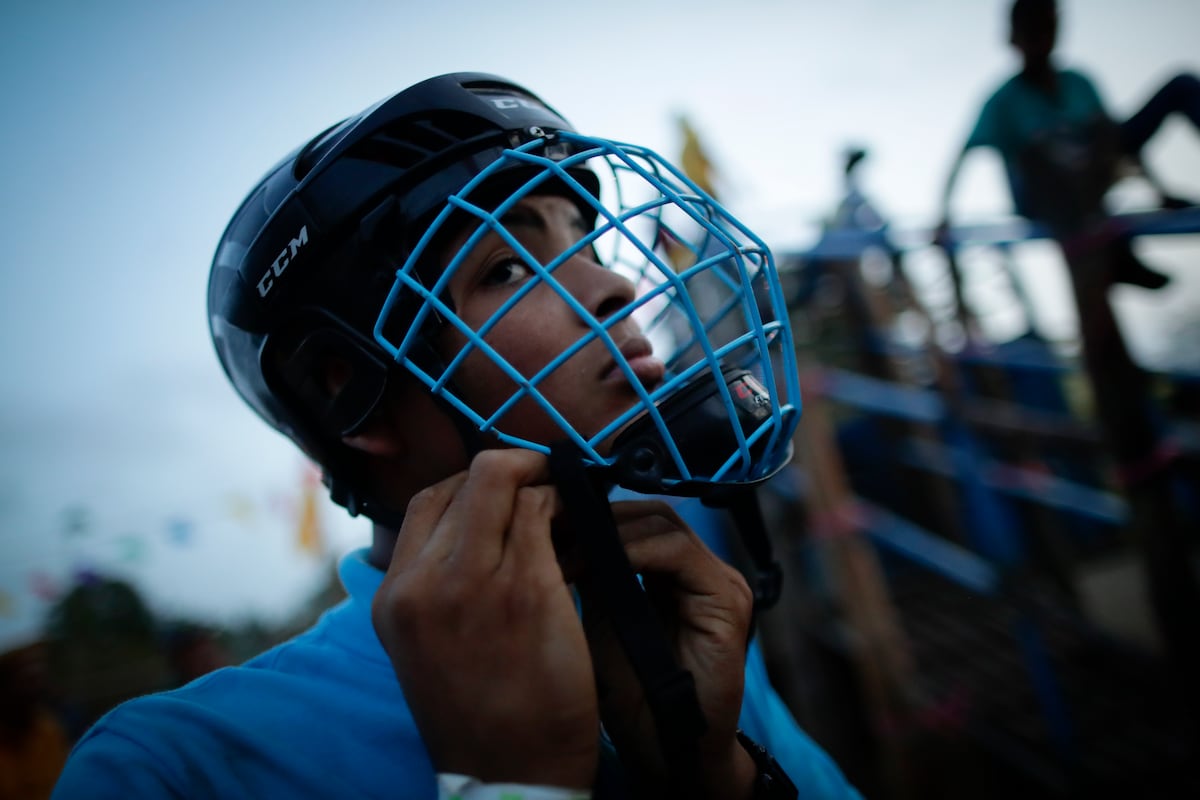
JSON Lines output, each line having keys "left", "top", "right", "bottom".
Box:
{"left": 0, "top": 0, "right": 1200, "bottom": 644}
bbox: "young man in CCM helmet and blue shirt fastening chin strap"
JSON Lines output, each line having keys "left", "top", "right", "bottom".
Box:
{"left": 58, "top": 74, "right": 857, "bottom": 800}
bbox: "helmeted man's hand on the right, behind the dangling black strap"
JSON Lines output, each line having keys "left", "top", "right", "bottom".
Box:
{"left": 580, "top": 501, "right": 755, "bottom": 799}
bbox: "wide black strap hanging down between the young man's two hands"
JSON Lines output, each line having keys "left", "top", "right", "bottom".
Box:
{"left": 550, "top": 441, "right": 708, "bottom": 786}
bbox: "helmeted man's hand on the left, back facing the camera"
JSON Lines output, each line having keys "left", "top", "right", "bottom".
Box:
{"left": 372, "top": 450, "right": 600, "bottom": 788}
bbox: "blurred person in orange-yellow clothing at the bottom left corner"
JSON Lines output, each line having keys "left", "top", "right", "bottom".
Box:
{"left": 0, "top": 642, "right": 70, "bottom": 800}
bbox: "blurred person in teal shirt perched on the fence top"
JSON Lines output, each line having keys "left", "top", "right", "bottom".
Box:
{"left": 937, "top": 0, "right": 1200, "bottom": 289}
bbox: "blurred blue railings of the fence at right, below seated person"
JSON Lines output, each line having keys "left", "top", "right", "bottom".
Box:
{"left": 779, "top": 207, "right": 1200, "bottom": 763}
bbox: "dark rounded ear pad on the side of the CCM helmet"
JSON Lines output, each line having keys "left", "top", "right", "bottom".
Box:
{"left": 274, "top": 326, "right": 391, "bottom": 440}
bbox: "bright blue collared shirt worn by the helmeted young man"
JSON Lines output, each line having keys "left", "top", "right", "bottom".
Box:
{"left": 54, "top": 551, "right": 858, "bottom": 800}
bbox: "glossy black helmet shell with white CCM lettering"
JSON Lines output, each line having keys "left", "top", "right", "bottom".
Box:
{"left": 208, "top": 73, "right": 595, "bottom": 513}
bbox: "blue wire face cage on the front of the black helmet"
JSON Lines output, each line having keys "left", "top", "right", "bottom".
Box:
{"left": 374, "top": 131, "right": 800, "bottom": 494}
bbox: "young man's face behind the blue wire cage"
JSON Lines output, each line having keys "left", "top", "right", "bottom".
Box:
{"left": 439, "top": 196, "right": 665, "bottom": 453}
